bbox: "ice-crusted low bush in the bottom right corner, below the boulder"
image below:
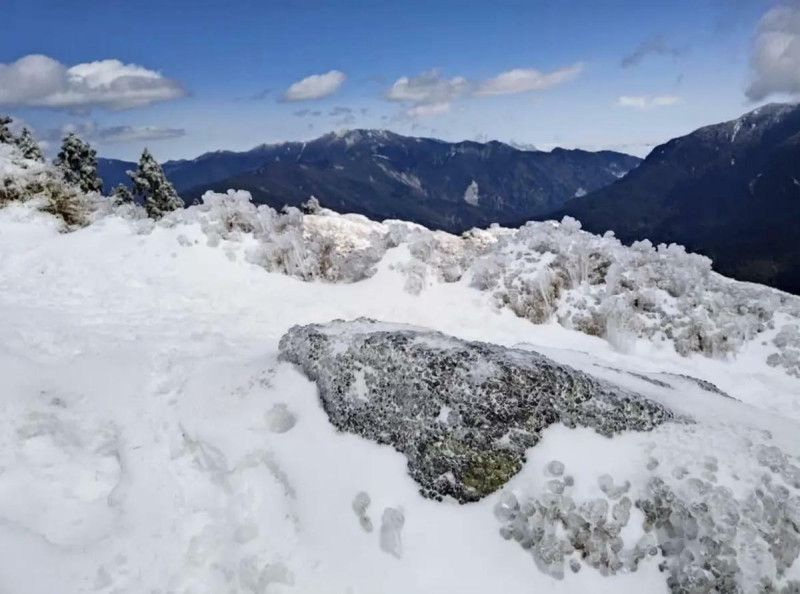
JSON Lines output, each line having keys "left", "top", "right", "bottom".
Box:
{"left": 494, "top": 439, "right": 800, "bottom": 594}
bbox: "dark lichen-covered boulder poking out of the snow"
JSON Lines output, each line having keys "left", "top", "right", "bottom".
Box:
{"left": 280, "top": 319, "right": 673, "bottom": 503}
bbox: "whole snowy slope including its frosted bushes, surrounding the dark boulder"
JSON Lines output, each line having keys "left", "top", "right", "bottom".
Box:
{"left": 0, "top": 143, "right": 800, "bottom": 594}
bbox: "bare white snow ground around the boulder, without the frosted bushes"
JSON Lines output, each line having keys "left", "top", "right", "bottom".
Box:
{"left": 0, "top": 145, "right": 800, "bottom": 594}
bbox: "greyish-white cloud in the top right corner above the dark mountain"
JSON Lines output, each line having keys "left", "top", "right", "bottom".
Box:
{"left": 745, "top": 5, "right": 800, "bottom": 101}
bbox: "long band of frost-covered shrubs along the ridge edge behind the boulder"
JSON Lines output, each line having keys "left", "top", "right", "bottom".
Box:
{"left": 159, "top": 191, "right": 800, "bottom": 377}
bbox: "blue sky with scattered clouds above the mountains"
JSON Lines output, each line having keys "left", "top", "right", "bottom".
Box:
{"left": 0, "top": 0, "right": 800, "bottom": 160}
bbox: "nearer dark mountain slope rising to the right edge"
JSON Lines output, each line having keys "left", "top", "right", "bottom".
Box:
{"left": 553, "top": 104, "right": 800, "bottom": 293}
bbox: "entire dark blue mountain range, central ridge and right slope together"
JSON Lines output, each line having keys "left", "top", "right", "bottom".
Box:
{"left": 98, "top": 104, "right": 800, "bottom": 293}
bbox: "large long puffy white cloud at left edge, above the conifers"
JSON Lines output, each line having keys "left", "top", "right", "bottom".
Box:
{"left": 0, "top": 54, "right": 186, "bottom": 110}
